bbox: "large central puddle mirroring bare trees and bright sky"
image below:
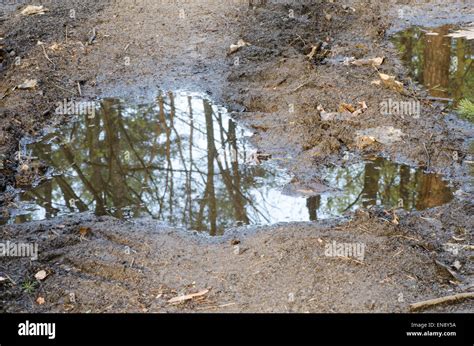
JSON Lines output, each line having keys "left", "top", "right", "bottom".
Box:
{"left": 0, "top": 93, "right": 453, "bottom": 235}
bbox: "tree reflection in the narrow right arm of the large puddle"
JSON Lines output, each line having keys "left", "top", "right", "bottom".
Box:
{"left": 316, "top": 158, "right": 453, "bottom": 219}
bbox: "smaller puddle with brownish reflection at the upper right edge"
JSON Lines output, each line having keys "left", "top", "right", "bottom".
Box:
{"left": 392, "top": 25, "right": 474, "bottom": 108}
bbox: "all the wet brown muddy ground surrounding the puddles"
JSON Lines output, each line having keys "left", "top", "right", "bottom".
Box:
{"left": 0, "top": 0, "right": 474, "bottom": 312}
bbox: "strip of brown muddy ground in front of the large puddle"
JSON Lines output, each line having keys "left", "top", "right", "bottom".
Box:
{"left": 2, "top": 199, "right": 472, "bottom": 312}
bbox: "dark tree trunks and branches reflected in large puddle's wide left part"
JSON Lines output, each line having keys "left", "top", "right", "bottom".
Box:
{"left": 24, "top": 93, "right": 278, "bottom": 234}
